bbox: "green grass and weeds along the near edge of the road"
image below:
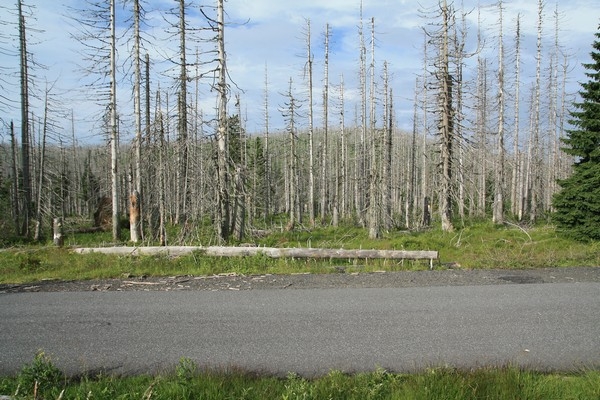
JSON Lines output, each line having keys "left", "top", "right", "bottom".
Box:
{"left": 0, "top": 352, "right": 600, "bottom": 400}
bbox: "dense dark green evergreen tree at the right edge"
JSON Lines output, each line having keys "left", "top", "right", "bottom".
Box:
{"left": 553, "top": 27, "right": 600, "bottom": 240}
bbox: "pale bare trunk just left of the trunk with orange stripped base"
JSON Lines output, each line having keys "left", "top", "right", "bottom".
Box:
{"left": 110, "top": 0, "right": 120, "bottom": 241}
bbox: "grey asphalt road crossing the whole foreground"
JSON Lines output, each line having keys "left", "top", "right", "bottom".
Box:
{"left": 0, "top": 282, "right": 600, "bottom": 376}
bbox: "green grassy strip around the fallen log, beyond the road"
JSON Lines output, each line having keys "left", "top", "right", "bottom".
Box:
{"left": 0, "top": 223, "right": 600, "bottom": 283}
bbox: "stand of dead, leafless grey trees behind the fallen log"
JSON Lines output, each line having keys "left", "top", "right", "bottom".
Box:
{"left": 0, "top": 0, "right": 575, "bottom": 245}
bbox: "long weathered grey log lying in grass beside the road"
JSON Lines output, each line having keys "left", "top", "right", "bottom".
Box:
{"left": 74, "top": 246, "right": 439, "bottom": 268}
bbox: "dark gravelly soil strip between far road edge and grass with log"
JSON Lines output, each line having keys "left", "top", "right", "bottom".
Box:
{"left": 0, "top": 266, "right": 600, "bottom": 293}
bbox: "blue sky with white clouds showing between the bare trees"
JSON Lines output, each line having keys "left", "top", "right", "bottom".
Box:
{"left": 0, "top": 0, "right": 600, "bottom": 141}
